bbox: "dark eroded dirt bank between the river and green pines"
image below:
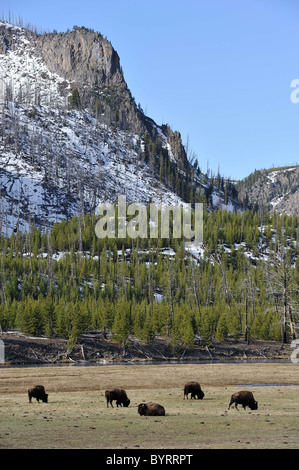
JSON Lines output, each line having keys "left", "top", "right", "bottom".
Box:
{"left": 0, "top": 333, "right": 293, "bottom": 364}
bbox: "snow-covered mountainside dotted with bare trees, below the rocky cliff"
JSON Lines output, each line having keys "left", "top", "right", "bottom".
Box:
{"left": 0, "top": 24, "right": 189, "bottom": 234}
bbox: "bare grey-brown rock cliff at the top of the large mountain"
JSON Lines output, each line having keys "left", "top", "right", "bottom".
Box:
{"left": 36, "top": 27, "right": 188, "bottom": 167}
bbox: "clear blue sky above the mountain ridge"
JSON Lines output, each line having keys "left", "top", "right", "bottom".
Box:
{"left": 0, "top": 0, "right": 299, "bottom": 179}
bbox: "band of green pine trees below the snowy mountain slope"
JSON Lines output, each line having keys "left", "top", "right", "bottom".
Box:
{"left": 0, "top": 207, "right": 299, "bottom": 348}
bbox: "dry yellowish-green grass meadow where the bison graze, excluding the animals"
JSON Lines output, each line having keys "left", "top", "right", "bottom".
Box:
{"left": 0, "top": 363, "right": 299, "bottom": 449}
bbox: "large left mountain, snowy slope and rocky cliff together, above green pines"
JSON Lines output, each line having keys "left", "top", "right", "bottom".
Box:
{"left": 0, "top": 23, "right": 191, "bottom": 235}
